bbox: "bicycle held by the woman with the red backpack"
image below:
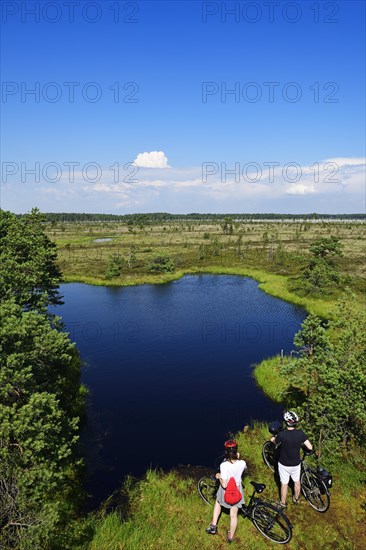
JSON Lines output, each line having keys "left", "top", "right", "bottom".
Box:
{"left": 198, "top": 476, "right": 292, "bottom": 544}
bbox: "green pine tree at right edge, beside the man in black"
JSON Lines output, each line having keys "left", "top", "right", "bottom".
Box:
{"left": 282, "top": 298, "right": 366, "bottom": 458}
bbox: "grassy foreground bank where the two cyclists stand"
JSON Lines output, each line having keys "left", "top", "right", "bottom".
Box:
{"left": 87, "top": 424, "right": 366, "bottom": 550}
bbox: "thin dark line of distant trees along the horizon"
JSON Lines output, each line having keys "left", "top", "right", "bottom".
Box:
{"left": 20, "top": 212, "right": 366, "bottom": 225}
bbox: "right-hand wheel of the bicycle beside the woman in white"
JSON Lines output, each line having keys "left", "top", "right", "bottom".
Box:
{"left": 252, "top": 501, "right": 292, "bottom": 544}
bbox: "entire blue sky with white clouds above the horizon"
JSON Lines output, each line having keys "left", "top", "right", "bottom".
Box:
{"left": 1, "top": 0, "right": 365, "bottom": 213}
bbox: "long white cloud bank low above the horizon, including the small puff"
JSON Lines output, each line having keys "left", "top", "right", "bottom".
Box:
{"left": 3, "top": 157, "right": 366, "bottom": 216}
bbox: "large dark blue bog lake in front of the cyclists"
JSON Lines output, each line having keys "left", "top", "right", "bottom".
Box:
{"left": 54, "top": 275, "right": 306, "bottom": 504}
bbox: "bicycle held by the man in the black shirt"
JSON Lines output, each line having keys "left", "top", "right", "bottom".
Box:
{"left": 262, "top": 423, "right": 333, "bottom": 513}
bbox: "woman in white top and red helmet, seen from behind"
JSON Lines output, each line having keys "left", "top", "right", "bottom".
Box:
{"left": 206, "top": 441, "right": 247, "bottom": 542}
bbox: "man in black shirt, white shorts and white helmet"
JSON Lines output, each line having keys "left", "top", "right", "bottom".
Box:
{"left": 271, "top": 411, "right": 313, "bottom": 507}
